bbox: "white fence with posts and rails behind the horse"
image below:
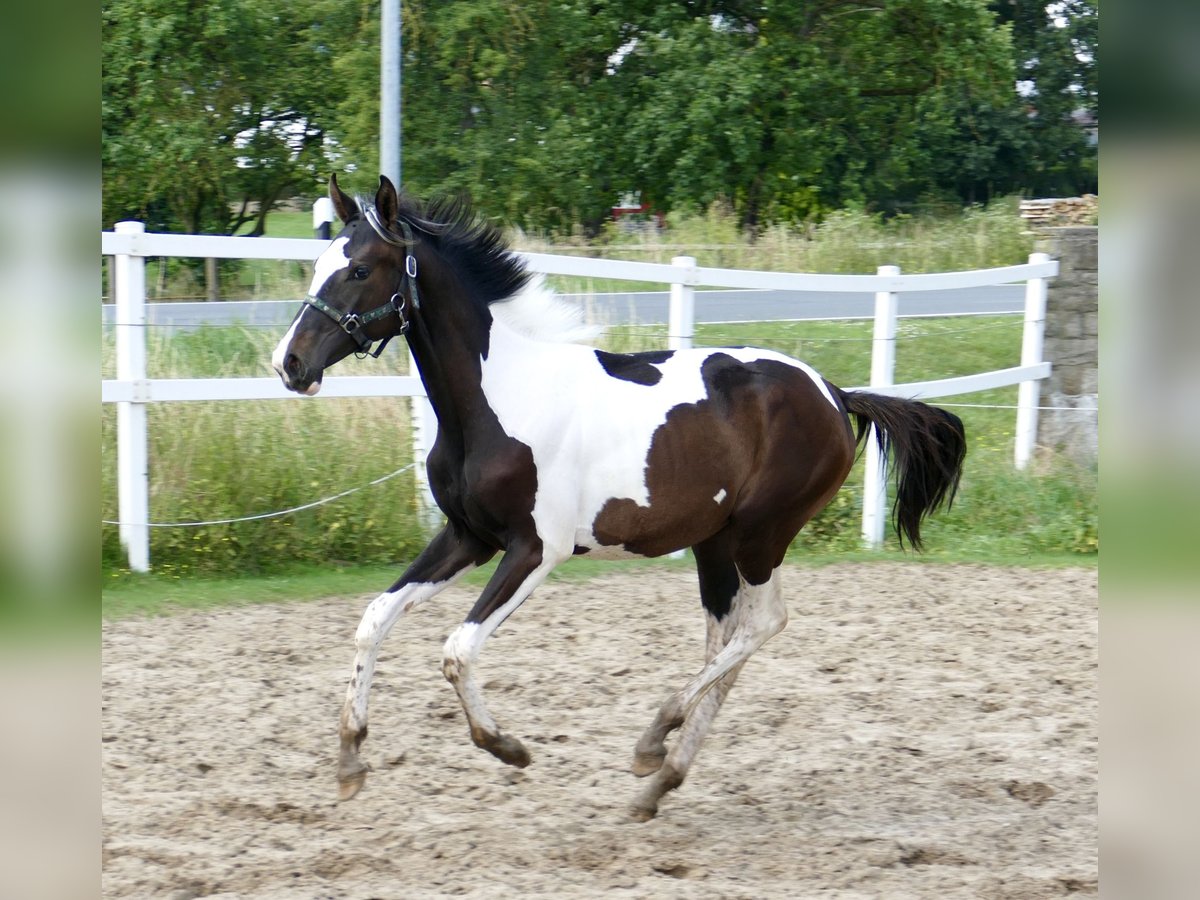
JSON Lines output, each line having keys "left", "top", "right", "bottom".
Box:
{"left": 101, "top": 222, "right": 1058, "bottom": 571}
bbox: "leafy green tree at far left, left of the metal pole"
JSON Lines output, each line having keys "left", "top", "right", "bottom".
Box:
{"left": 102, "top": 0, "right": 353, "bottom": 234}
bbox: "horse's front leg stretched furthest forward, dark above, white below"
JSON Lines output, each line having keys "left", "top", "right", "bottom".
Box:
{"left": 337, "top": 524, "right": 494, "bottom": 800}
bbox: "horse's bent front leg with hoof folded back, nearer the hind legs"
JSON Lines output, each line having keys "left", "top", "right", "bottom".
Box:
{"left": 442, "top": 547, "right": 559, "bottom": 769}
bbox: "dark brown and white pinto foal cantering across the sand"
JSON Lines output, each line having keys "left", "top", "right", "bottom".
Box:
{"left": 271, "top": 175, "right": 966, "bottom": 821}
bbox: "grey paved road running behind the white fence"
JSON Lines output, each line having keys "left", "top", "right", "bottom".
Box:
{"left": 103, "top": 284, "right": 1025, "bottom": 329}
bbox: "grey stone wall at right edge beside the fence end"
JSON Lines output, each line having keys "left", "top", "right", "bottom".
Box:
{"left": 1038, "top": 226, "right": 1099, "bottom": 463}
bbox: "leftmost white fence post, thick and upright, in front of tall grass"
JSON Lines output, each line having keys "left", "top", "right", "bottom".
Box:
{"left": 113, "top": 222, "right": 150, "bottom": 572}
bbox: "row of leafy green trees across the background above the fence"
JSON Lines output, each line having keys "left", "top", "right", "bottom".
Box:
{"left": 103, "top": 0, "right": 1096, "bottom": 236}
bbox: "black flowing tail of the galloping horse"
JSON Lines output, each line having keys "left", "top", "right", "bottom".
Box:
{"left": 838, "top": 390, "right": 967, "bottom": 550}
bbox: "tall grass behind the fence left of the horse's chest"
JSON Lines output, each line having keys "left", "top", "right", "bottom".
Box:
{"left": 101, "top": 328, "right": 424, "bottom": 576}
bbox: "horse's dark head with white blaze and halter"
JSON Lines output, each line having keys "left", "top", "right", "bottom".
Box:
{"left": 271, "top": 175, "right": 418, "bottom": 395}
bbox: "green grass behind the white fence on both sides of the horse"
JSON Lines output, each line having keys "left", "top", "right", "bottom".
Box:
{"left": 101, "top": 317, "right": 1098, "bottom": 576}
